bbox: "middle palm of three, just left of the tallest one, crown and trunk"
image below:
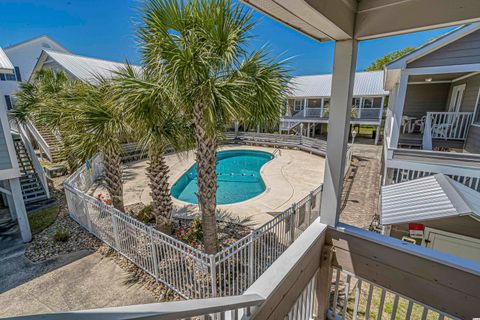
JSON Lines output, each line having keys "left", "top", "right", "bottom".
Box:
{"left": 109, "top": 65, "right": 191, "bottom": 234}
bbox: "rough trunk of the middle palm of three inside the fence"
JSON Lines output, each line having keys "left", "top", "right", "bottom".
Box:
{"left": 147, "top": 151, "right": 173, "bottom": 234}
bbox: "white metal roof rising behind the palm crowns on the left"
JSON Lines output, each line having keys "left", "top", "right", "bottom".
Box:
{"left": 39, "top": 50, "right": 140, "bottom": 83}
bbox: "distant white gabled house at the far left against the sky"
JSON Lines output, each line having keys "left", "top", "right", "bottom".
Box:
{"left": 0, "top": 35, "right": 69, "bottom": 110}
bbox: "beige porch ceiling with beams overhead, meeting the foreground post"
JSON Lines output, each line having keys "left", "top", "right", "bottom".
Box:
{"left": 241, "top": 0, "right": 480, "bottom": 41}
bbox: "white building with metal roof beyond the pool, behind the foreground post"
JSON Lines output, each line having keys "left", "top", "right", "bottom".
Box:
{"left": 280, "top": 71, "right": 388, "bottom": 142}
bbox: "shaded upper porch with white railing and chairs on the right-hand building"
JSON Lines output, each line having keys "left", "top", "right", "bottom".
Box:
{"left": 396, "top": 69, "right": 476, "bottom": 150}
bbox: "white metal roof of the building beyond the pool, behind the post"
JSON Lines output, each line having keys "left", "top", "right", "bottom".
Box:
{"left": 290, "top": 71, "right": 388, "bottom": 97}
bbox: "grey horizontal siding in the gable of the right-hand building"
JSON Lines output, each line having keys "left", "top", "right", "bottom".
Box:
{"left": 408, "top": 30, "right": 480, "bottom": 68}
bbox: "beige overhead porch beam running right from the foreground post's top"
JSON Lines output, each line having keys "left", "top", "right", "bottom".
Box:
{"left": 355, "top": 0, "right": 480, "bottom": 40}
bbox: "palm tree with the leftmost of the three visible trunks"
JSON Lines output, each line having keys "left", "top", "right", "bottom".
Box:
{"left": 62, "top": 79, "right": 131, "bottom": 211}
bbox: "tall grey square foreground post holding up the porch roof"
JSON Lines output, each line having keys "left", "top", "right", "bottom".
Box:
{"left": 320, "top": 40, "right": 358, "bottom": 226}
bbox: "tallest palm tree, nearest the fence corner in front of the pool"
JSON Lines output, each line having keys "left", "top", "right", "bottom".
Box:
{"left": 139, "top": 0, "right": 288, "bottom": 253}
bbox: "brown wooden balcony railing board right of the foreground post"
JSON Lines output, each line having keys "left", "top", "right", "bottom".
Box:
{"left": 327, "top": 225, "right": 480, "bottom": 319}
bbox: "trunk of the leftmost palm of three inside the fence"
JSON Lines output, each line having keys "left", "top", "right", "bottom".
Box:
{"left": 103, "top": 153, "right": 125, "bottom": 212}
